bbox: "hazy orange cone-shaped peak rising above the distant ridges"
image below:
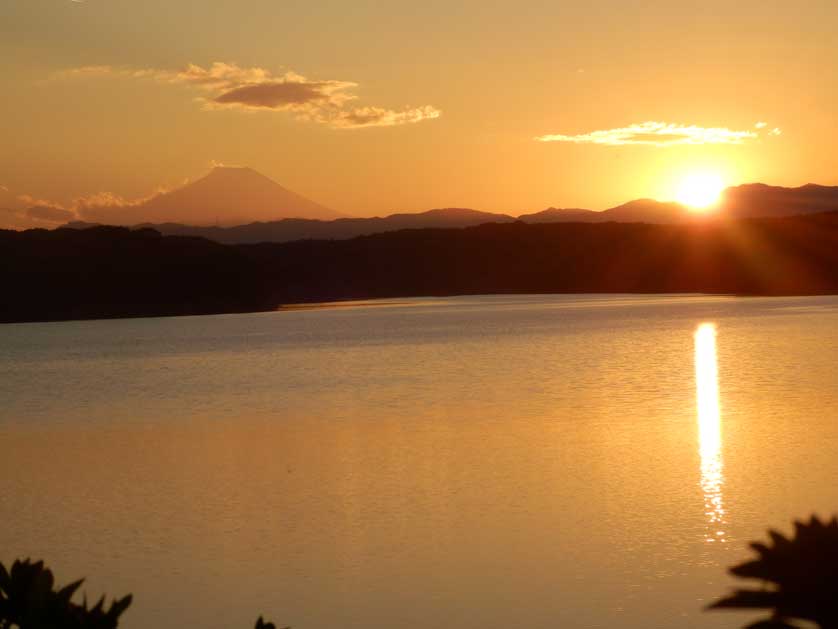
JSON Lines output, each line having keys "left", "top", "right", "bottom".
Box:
{"left": 79, "top": 167, "right": 342, "bottom": 225}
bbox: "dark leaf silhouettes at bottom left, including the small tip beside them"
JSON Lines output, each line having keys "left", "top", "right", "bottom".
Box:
{"left": 0, "top": 559, "right": 288, "bottom": 629}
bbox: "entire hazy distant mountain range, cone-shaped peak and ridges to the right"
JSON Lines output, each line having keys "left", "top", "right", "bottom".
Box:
{"left": 0, "top": 167, "right": 820, "bottom": 244}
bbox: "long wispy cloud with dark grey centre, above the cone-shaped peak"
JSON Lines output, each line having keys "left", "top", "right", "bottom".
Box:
{"left": 52, "top": 62, "right": 442, "bottom": 129}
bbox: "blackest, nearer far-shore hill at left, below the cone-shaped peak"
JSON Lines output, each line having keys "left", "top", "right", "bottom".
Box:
{"left": 0, "top": 227, "right": 272, "bottom": 321}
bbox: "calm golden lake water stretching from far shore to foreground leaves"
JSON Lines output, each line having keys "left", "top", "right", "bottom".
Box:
{"left": 0, "top": 296, "right": 838, "bottom": 629}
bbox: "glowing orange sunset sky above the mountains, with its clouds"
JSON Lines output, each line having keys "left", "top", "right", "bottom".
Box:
{"left": 0, "top": 0, "right": 838, "bottom": 221}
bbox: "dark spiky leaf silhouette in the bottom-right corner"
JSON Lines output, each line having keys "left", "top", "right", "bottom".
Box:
{"left": 710, "top": 516, "right": 838, "bottom": 629}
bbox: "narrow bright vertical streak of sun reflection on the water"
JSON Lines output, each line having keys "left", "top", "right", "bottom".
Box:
{"left": 695, "top": 323, "right": 725, "bottom": 543}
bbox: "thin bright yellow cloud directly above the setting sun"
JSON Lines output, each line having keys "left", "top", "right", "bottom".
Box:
{"left": 535, "top": 121, "right": 759, "bottom": 146}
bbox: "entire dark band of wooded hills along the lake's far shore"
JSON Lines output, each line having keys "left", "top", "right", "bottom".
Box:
{"left": 0, "top": 212, "right": 838, "bottom": 321}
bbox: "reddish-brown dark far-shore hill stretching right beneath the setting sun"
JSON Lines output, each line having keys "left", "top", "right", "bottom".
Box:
{"left": 251, "top": 213, "right": 838, "bottom": 302}
